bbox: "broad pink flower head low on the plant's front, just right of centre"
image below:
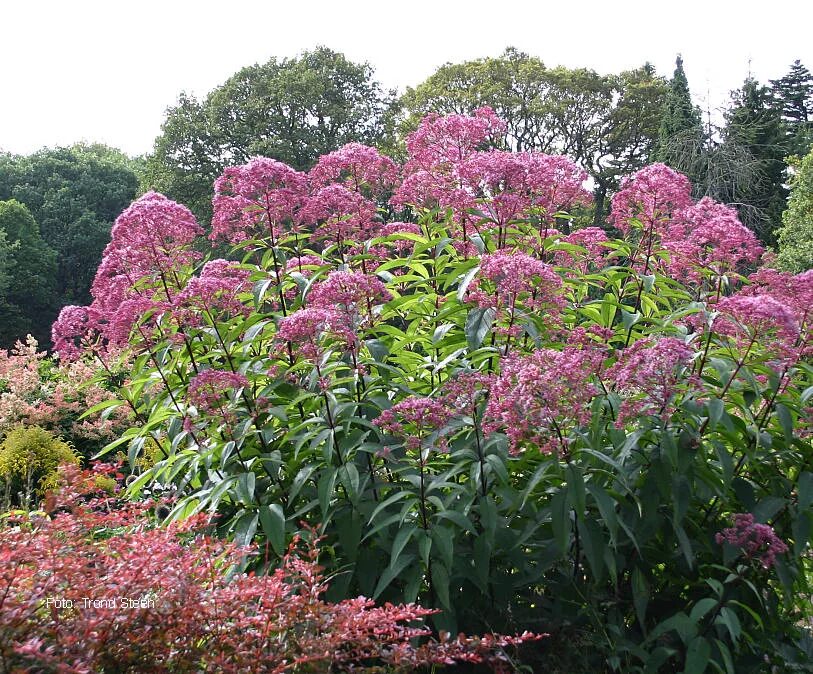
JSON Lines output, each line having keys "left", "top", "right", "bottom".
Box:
{"left": 483, "top": 347, "right": 604, "bottom": 454}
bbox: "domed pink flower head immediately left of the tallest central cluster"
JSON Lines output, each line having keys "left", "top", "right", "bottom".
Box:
{"left": 308, "top": 143, "right": 398, "bottom": 195}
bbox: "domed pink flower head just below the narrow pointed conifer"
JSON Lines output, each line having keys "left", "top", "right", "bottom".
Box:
{"left": 609, "top": 164, "right": 692, "bottom": 234}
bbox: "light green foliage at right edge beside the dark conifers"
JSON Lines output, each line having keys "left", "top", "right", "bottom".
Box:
{"left": 778, "top": 152, "right": 813, "bottom": 272}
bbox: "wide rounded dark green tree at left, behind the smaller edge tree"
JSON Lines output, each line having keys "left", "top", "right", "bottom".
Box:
{"left": 0, "top": 145, "right": 140, "bottom": 308}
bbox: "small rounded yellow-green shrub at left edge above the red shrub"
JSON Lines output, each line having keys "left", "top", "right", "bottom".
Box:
{"left": 0, "top": 426, "right": 79, "bottom": 509}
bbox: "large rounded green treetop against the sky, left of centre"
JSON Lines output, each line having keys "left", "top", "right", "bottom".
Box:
{"left": 143, "top": 47, "right": 393, "bottom": 220}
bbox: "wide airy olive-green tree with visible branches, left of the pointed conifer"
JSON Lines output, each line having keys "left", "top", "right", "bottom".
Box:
{"left": 399, "top": 47, "right": 666, "bottom": 224}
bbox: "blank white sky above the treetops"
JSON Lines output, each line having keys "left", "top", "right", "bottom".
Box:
{"left": 0, "top": 0, "right": 813, "bottom": 154}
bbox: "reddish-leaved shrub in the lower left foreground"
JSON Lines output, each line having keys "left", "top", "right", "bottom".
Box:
{"left": 0, "top": 466, "right": 540, "bottom": 674}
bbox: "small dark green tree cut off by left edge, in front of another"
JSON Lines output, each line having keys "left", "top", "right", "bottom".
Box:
{"left": 0, "top": 199, "right": 57, "bottom": 349}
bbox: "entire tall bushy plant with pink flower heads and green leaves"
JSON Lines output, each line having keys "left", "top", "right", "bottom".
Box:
{"left": 54, "top": 110, "right": 813, "bottom": 672}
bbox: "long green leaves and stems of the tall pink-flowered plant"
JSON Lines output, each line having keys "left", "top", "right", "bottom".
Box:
{"left": 100, "top": 202, "right": 813, "bottom": 673}
